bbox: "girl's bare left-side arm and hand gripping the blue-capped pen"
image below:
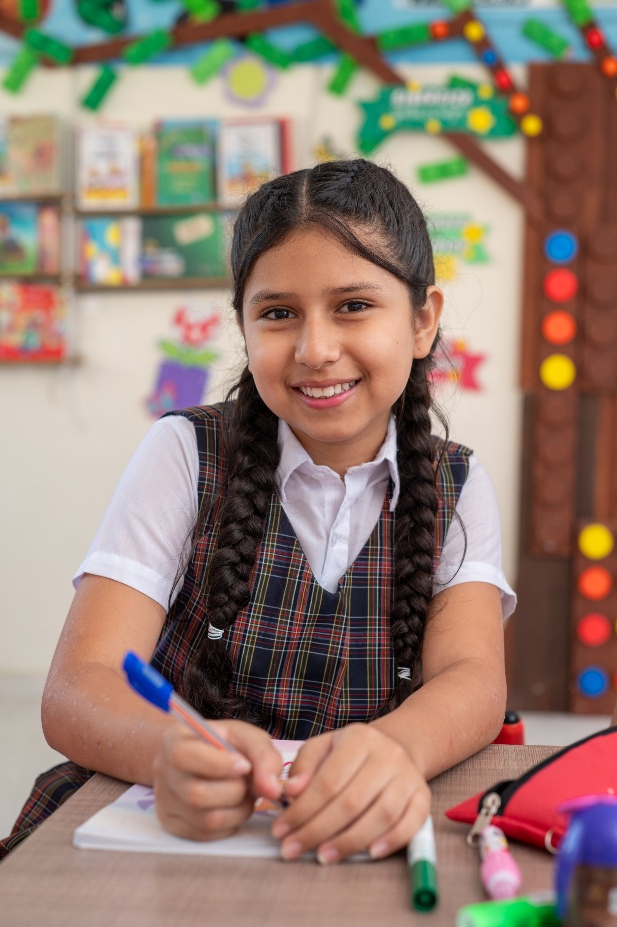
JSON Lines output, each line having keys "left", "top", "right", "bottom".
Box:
{"left": 42, "top": 574, "right": 281, "bottom": 840}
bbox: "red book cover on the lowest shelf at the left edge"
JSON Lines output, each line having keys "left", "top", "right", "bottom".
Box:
{"left": 0, "top": 282, "right": 66, "bottom": 363}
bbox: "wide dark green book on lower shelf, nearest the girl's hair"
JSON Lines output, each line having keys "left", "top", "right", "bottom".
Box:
{"left": 141, "top": 213, "right": 226, "bottom": 277}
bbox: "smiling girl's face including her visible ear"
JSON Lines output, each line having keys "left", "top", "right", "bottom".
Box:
{"left": 242, "top": 228, "right": 443, "bottom": 473}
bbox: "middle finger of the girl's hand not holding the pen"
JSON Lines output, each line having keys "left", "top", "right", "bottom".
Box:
{"left": 281, "top": 757, "right": 398, "bottom": 859}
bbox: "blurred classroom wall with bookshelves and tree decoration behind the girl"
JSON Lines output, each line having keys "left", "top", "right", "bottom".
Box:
{"left": 0, "top": 0, "right": 617, "bottom": 835}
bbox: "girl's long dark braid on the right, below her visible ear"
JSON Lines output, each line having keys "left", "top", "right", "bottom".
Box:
{"left": 387, "top": 355, "right": 438, "bottom": 711}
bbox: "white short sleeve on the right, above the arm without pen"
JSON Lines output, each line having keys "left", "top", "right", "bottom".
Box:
{"left": 433, "top": 455, "right": 516, "bottom": 620}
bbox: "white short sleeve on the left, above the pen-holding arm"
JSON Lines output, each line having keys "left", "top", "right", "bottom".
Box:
{"left": 73, "top": 416, "right": 199, "bottom": 610}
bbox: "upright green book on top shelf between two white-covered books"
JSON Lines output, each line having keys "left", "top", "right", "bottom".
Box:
{"left": 156, "top": 119, "right": 218, "bottom": 206}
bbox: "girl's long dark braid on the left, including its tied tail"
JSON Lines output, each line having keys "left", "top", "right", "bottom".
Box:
{"left": 183, "top": 368, "right": 279, "bottom": 718}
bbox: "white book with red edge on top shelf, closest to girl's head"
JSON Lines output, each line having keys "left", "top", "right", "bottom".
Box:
{"left": 217, "top": 119, "right": 291, "bottom": 206}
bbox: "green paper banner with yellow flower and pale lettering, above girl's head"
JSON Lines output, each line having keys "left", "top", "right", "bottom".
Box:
{"left": 358, "top": 84, "right": 516, "bottom": 154}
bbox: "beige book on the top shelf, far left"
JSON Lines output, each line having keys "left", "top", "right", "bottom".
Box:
{"left": 7, "top": 116, "right": 63, "bottom": 196}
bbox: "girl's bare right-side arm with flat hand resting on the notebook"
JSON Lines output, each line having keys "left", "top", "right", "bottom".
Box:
{"left": 273, "top": 582, "right": 506, "bottom": 862}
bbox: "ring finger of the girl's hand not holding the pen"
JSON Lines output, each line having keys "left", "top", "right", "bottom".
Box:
{"left": 317, "top": 778, "right": 417, "bottom": 864}
